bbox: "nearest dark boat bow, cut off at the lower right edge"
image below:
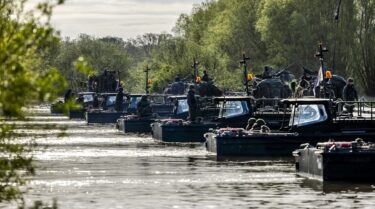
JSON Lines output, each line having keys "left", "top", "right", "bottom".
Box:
{"left": 293, "top": 139, "right": 375, "bottom": 182}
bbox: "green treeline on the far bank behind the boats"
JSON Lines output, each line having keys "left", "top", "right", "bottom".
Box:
{"left": 51, "top": 0, "right": 375, "bottom": 96}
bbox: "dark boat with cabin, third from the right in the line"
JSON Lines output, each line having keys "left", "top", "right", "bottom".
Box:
{"left": 151, "top": 96, "right": 283, "bottom": 143}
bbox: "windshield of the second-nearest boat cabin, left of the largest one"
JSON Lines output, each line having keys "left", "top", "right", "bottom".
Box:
{"left": 220, "top": 101, "right": 249, "bottom": 118}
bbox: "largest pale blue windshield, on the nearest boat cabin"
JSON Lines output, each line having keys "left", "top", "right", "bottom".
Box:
{"left": 289, "top": 104, "right": 328, "bottom": 126}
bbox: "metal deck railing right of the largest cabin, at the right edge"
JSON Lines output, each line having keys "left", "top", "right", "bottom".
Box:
{"left": 334, "top": 99, "right": 375, "bottom": 120}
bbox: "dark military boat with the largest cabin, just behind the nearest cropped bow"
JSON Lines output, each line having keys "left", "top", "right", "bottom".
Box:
{"left": 205, "top": 98, "right": 375, "bottom": 158}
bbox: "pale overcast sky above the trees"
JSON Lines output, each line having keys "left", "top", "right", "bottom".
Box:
{"left": 44, "top": 0, "right": 204, "bottom": 39}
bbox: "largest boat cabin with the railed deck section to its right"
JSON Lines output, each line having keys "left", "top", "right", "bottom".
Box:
{"left": 281, "top": 99, "right": 375, "bottom": 132}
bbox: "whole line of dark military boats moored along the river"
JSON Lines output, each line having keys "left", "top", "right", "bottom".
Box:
{"left": 51, "top": 47, "right": 375, "bottom": 181}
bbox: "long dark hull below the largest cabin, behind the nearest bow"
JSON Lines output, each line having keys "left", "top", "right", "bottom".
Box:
{"left": 205, "top": 132, "right": 375, "bottom": 157}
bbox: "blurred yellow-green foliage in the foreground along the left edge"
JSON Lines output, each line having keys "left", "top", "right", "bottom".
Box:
{"left": 0, "top": 0, "right": 66, "bottom": 202}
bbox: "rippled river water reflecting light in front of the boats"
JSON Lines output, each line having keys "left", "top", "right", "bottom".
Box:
{"left": 2, "top": 107, "right": 375, "bottom": 209}
